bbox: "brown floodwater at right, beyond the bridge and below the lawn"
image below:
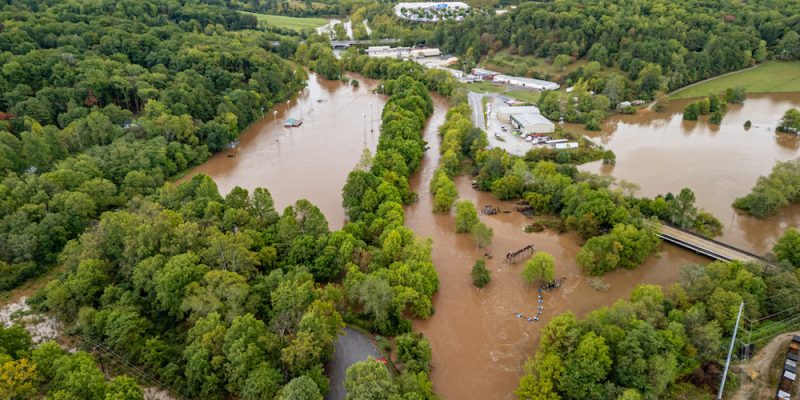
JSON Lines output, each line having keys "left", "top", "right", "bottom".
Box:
{"left": 569, "top": 93, "right": 800, "bottom": 254}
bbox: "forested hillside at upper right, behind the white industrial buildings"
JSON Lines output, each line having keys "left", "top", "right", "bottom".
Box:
{"left": 430, "top": 0, "right": 800, "bottom": 95}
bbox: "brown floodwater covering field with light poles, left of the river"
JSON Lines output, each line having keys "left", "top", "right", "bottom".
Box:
{"left": 182, "top": 73, "right": 386, "bottom": 229}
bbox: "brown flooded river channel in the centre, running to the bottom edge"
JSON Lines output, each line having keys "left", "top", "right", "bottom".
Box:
{"left": 406, "top": 97, "right": 707, "bottom": 400}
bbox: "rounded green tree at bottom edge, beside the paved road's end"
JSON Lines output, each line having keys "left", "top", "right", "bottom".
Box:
{"left": 344, "top": 357, "right": 397, "bottom": 400}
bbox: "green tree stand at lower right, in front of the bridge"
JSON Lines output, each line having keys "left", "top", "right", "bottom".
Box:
{"left": 517, "top": 241, "right": 800, "bottom": 400}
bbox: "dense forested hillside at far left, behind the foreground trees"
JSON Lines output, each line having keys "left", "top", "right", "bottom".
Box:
{"left": 0, "top": 0, "right": 305, "bottom": 290}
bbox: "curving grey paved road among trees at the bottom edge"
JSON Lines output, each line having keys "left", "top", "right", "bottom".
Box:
{"left": 325, "top": 327, "right": 383, "bottom": 400}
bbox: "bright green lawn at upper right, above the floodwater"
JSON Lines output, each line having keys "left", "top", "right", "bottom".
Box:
{"left": 669, "top": 61, "right": 800, "bottom": 99}
